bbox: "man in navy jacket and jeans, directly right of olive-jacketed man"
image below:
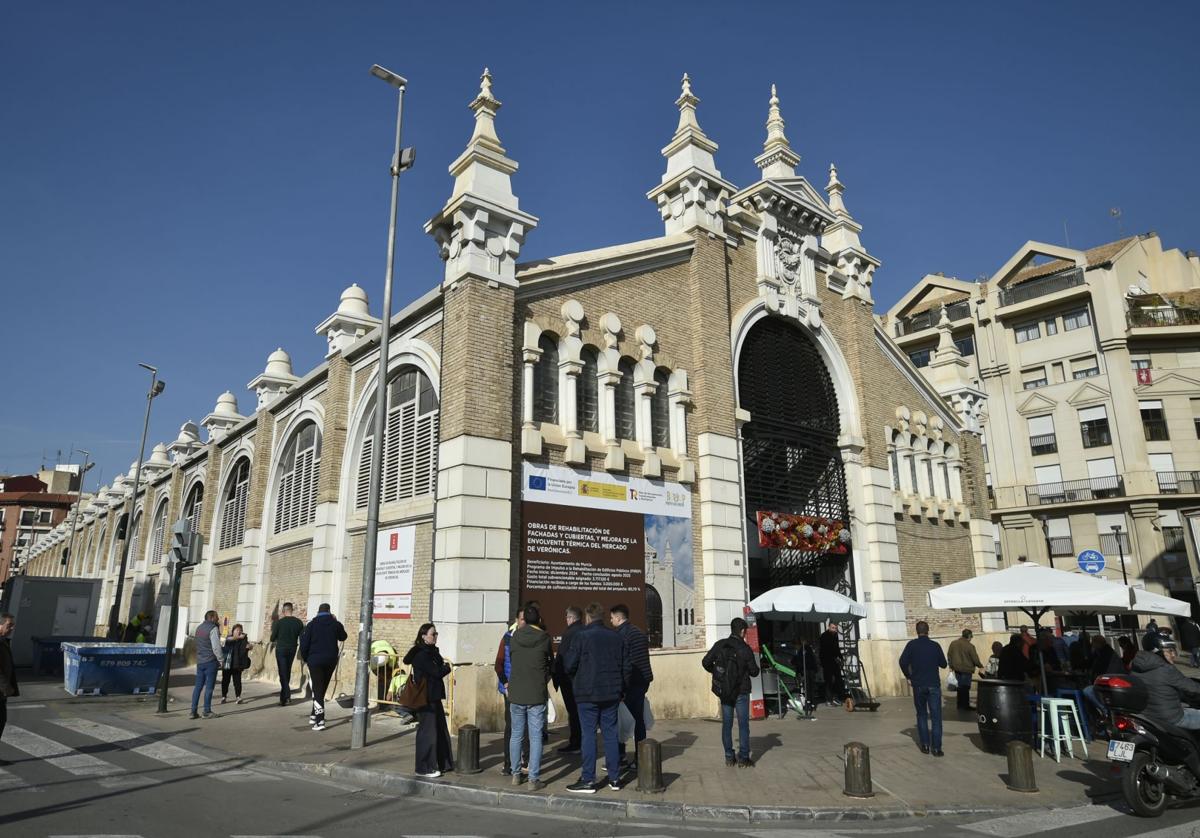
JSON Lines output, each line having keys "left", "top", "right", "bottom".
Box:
{"left": 563, "top": 603, "right": 632, "bottom": 795}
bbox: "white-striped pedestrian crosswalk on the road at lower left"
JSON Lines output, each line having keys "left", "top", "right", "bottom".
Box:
{"left": 0, "top": 718, "right": 280, "bottom": 792}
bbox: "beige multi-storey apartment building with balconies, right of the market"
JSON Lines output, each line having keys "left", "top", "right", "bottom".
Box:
{"left": 882, "top": 233, "right": 1200, "bottom": 611}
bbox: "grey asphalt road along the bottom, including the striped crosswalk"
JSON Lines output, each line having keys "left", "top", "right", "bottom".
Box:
{"left": 0, "top": 700, "right": 1200, "bottom": 838}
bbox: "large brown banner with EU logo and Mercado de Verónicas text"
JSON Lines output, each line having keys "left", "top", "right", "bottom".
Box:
{"left": 521, "top": 463, "right": 700, "bottom": 648}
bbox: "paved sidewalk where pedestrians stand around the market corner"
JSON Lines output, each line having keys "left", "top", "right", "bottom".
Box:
{"left": 103, "top": 672, "right": 1118, "bottom": 820}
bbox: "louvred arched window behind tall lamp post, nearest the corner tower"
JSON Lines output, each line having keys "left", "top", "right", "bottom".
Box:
{"left": 354, "top": 367, "right": 438, "bottom": 509}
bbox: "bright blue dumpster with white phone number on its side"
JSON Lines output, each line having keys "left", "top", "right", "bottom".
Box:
{"left": 62, "top": 641, "right": 167, "bottom": 695}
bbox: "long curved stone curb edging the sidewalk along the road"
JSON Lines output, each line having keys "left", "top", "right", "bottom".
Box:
{"left": 257, "top": 760, "right": 1098, "bottom": 824}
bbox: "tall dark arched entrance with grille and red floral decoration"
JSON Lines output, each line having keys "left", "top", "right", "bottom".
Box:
{"left": 738, "top": 317, "right": 854, "bottom": 597}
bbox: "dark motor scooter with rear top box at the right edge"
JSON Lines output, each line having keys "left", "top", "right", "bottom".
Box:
{"left": 1093, "top": 675, "right": 1200, "bottom": 818}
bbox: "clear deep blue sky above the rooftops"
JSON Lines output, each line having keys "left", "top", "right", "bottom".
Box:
{"left": 0, "top": 0, "right": 1200, "bottom": 489}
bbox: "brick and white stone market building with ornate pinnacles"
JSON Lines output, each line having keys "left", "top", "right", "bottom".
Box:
{"left": 29, "top": 71, "right": 995, "bottom": 725}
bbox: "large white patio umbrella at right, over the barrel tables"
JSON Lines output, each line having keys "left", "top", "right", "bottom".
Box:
{"left": 929, "top": 562, "right": 1192, "bottom": 693}
